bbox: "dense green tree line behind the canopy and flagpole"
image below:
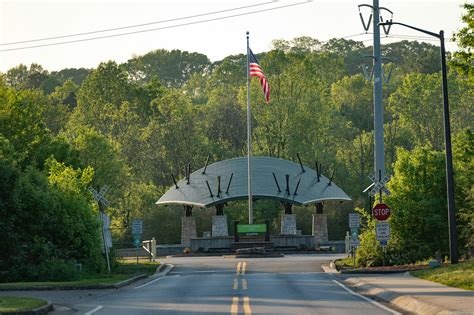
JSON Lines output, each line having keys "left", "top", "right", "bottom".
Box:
{"left": 0, "top": 6, "right": 474, "bottom": 279}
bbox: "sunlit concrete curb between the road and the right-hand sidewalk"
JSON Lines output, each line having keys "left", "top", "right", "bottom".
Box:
{"left": 343, "top": 278, "right": 459, "bottom": 315}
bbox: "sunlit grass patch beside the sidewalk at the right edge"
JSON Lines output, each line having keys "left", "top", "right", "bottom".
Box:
{"left": 411, "top": 260, "right": 474, "bottom": 290}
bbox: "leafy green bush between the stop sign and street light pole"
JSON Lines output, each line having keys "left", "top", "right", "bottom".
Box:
{"left": 387, "top": 146, "right": 449, "bottom": 262}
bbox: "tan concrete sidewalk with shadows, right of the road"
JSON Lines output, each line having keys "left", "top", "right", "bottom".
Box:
{"left": 340, "top": 272, "right": 474, "bottom": 315}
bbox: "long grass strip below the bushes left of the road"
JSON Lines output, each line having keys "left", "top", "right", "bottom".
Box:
{"left": 0, "top": 261, "right": 160, "bottom": 290}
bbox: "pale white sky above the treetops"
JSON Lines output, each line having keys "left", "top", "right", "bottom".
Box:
{"left": 0, "top": 0, "right": 466, "bottom": 72}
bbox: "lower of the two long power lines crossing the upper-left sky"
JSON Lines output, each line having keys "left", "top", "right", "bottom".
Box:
{"left": 0, "top": 0, "right": 313, "bottom": 52}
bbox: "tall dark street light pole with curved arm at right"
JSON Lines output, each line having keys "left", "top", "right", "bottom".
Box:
{"left": 379, "top": 21, "right": 459, "bottom": 264}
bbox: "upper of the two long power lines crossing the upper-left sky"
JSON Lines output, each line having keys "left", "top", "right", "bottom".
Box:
{"left": 0, "top": 0, "right": 279, "bottom": 46}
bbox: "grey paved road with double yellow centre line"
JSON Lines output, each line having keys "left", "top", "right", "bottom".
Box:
{"left": 9, "top": 255, "right": 402, "bottom": 315}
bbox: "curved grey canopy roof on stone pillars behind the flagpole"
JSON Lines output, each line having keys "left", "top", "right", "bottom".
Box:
{"left": 156, "top": 156, "right": 351, "bottom": 207}
